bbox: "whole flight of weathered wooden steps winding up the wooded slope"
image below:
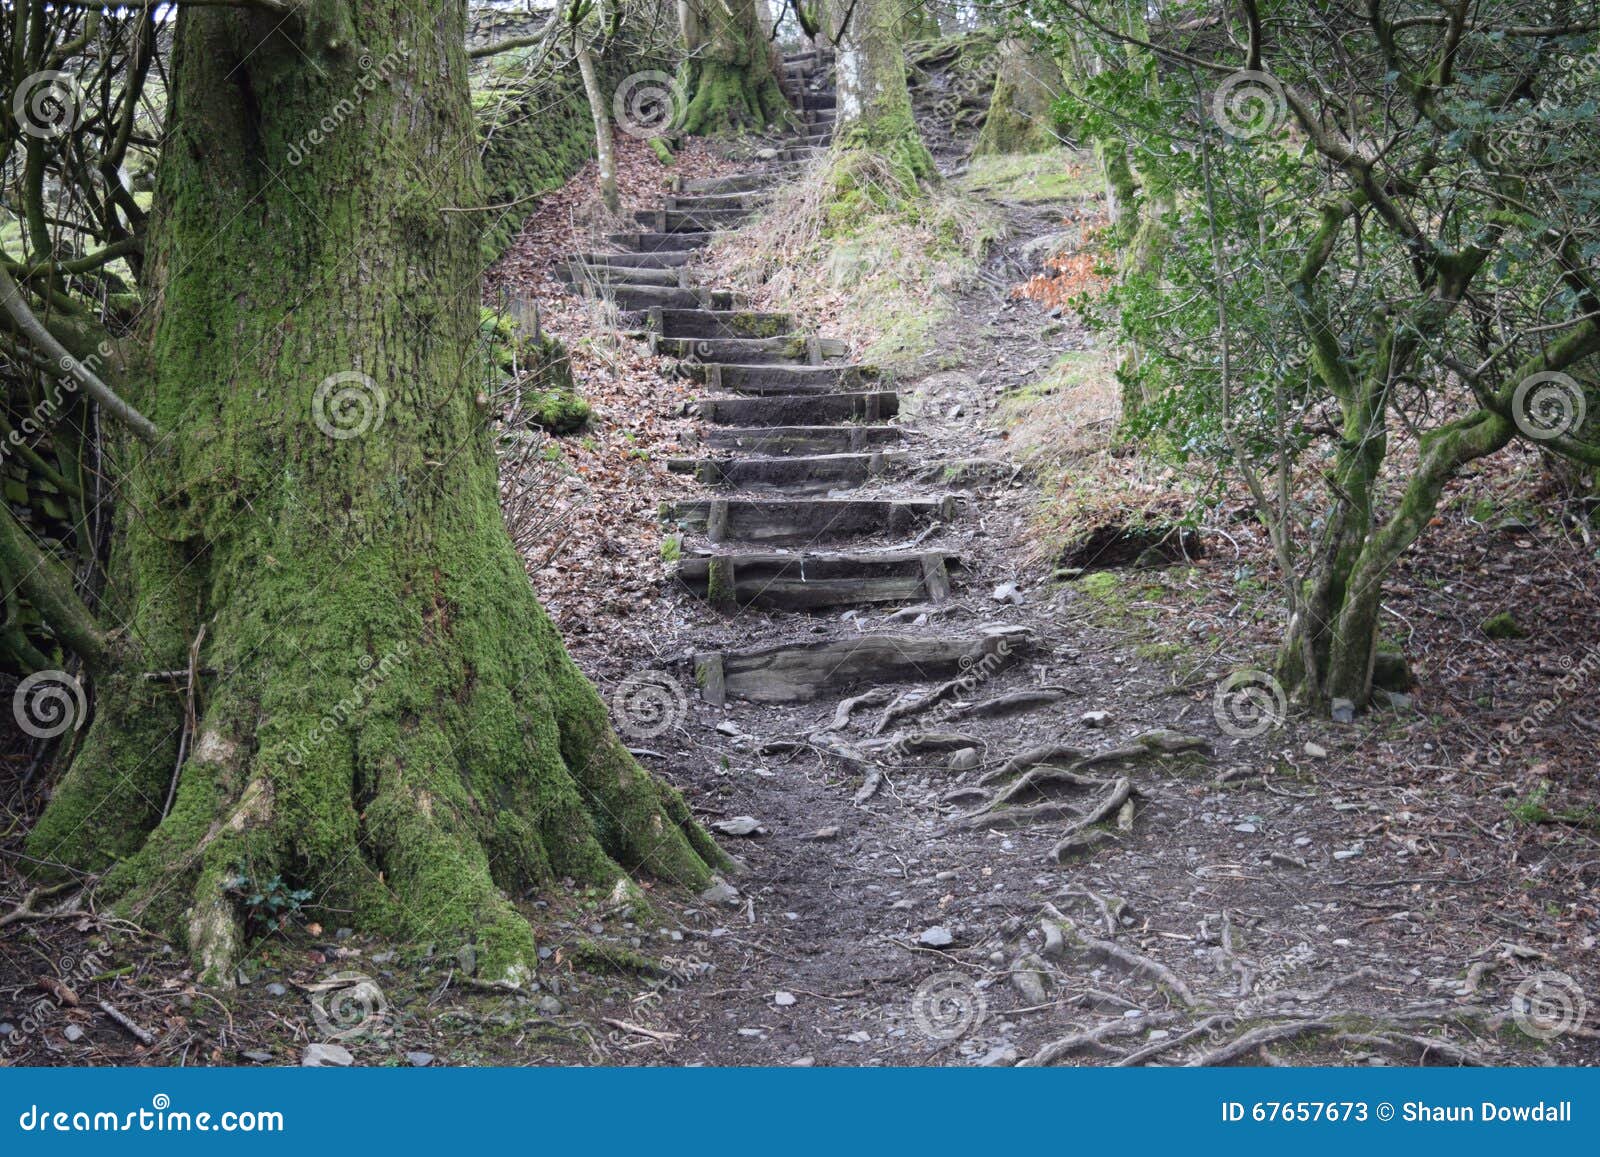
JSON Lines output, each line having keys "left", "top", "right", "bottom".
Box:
{"left": 565, "top": 51, "right": 1026, "bottom": 704}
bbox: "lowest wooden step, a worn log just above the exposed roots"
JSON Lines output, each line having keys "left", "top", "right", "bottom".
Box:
{"left": 694, "top": 626, "right": 1034, "bottom": 706}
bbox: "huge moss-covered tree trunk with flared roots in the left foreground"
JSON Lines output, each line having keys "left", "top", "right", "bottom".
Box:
{"left": 29, "top": 0, "right": 718, "bottom": 981}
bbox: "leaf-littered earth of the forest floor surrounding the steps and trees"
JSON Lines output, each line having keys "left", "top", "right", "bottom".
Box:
{"left": 0, "top": 72, "right": 1600, "bottom": 1064}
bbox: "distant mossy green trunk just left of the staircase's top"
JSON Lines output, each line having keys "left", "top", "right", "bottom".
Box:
{"left": 678, "top": 0, "right": 789, "bottom": 136}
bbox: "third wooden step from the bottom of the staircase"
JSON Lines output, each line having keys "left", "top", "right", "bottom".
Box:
{"left": 662, "top": 496, "right": 957, "bottom": 546}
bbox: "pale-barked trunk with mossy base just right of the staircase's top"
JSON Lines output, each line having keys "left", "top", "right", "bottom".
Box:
{"left": 834, "top": 0, "right": 938, "bottom": 182}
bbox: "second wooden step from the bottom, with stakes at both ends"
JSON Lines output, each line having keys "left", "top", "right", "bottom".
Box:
{"left": 677, "top": 550, "right": 962, "bottom": 611}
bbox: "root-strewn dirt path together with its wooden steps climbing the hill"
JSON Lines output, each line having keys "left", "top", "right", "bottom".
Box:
{"left": 556, "top": 53, "right": 1555, "bottom": 1066}
